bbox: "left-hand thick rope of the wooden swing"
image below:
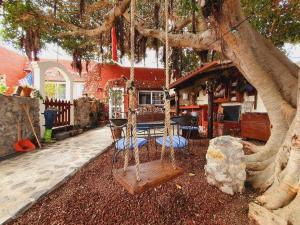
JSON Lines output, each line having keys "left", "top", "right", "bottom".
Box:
{"left": 124, "top": 0, "right": 141, "bottom": 181}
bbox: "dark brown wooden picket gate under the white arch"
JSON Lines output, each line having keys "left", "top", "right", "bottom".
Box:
{"left": 44, "top": 98, "right": 72, "bottom": 127}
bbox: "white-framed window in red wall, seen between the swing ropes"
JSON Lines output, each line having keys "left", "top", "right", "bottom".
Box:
{"left": 139, "top": 91, "right": 164, "bottom": 105}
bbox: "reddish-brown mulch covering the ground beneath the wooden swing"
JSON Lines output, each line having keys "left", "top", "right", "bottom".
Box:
{"left": 9, "top": 140, "right": 255, "bottom": 225}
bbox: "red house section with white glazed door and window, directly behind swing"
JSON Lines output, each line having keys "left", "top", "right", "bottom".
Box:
{"left": 85, "top": 64, "right": 165, "bottom": 118}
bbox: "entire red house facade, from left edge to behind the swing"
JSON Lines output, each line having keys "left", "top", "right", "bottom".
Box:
{"left": 0, "top": 47, "right": 165, "bottom": 117}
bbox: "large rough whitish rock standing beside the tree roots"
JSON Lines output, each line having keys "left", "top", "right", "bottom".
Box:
{"left": 204, "top": 136, "right": 246, "bottom": 195}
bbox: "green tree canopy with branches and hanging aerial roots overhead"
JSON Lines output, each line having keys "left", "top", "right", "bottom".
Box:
{"left": 1, "top": 0, "right": 300, "bottom": 75}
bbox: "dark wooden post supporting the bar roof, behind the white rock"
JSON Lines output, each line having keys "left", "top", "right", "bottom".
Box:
{"left": 207, "top": 80, "right": 214, "bottom": 139}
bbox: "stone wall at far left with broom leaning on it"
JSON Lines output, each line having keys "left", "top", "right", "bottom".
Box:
{"left": 0, "top": 95, "right": 40, "bottom": 157}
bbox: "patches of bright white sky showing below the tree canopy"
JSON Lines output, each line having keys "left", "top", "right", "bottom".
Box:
{"left": 0, "top": 40, "right": 300, "bottom": 68}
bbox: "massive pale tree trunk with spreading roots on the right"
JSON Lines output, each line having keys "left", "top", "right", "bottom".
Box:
{"left": 211, "top": 0, "right": 300, "bottom": 224}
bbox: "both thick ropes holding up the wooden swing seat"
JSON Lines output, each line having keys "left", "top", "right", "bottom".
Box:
{"left": 123, "top": 0, "right": 176, "bottom": 181}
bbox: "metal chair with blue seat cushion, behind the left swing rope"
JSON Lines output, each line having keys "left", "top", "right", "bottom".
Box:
{"left": 109, "top": 119, "right": 149, "bottom": 163}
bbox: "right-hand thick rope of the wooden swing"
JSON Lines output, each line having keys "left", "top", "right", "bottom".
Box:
{"left": 161, "top": 0, "right": 176, "bottom": 168}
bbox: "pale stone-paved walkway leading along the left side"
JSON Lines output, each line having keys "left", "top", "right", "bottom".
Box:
{"left": 0, "top": 128, "right": 112, "bottom": 224}
